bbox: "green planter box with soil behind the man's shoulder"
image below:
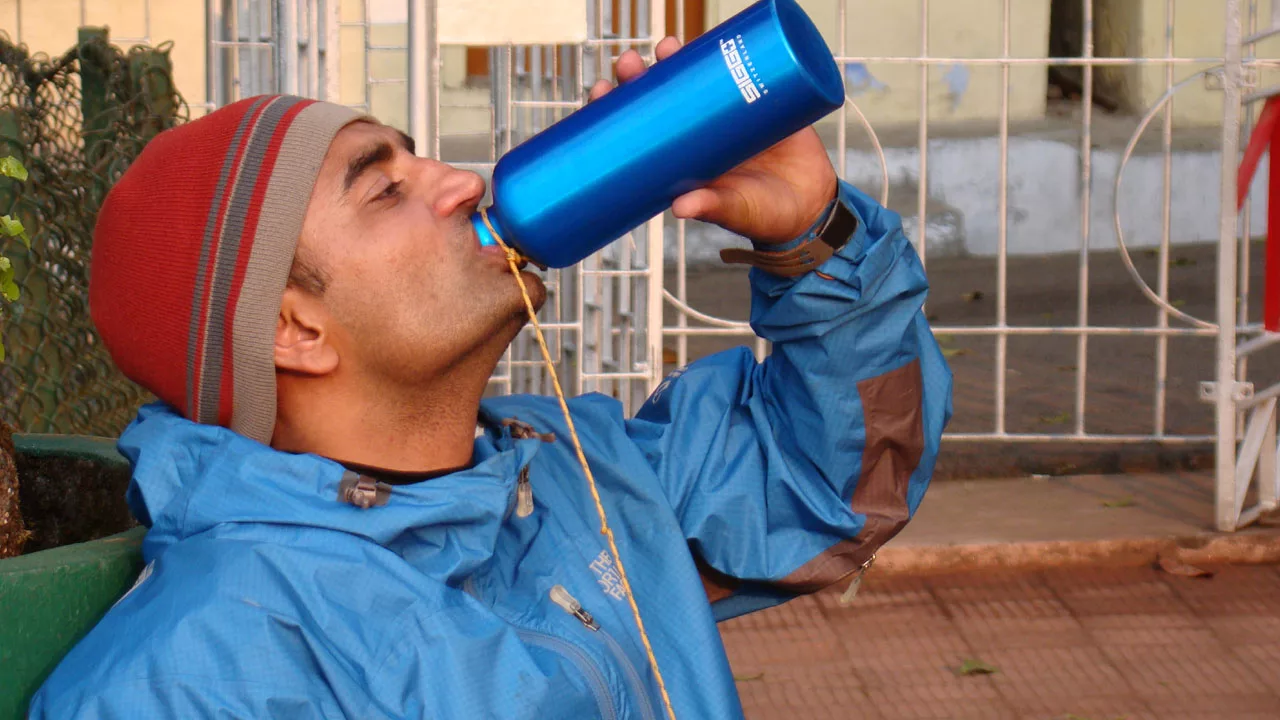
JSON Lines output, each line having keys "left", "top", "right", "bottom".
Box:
{"left": 0, "top": 436, "right": 145, "bottom": 720}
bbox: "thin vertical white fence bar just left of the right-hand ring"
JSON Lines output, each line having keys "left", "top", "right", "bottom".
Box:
{"left": 1075, "top": 0, "right": 1094, "bottom": 436}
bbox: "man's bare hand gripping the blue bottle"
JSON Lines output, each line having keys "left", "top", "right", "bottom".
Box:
{"left": 591, "top": 37, "right": 836, "bottom": 243}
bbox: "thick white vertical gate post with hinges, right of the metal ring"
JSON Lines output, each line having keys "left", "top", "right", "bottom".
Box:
{"left": 1215, "top": 0, "right": 1244, "bottom": 532}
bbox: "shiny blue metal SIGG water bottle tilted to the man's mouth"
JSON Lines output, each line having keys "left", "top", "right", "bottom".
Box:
{"left": 472, "top": 0, "right": 845, "bottom": 268}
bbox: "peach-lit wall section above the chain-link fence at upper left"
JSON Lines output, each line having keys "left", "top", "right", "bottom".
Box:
{"left": 0, "top": 0, "right": 205, "bottom": 117}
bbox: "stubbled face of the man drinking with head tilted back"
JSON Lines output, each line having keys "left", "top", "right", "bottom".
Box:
{"left": 287, "top": 122, "right": 545, "bottom": 386}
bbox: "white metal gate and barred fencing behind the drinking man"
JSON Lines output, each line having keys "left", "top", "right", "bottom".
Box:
{"left": 124, "top": 0, "right": 1280, "bottom": 530}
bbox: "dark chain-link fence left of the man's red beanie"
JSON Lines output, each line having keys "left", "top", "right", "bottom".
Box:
{"left": 0, "top": 28, "right": 188, "bottom": 436}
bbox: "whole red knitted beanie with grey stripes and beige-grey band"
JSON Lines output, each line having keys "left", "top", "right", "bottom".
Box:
{"left": 88, "top": 95, "right": 360, "bottom": 443}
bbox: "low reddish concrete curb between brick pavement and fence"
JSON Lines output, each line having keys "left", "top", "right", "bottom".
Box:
{"left": 872, "top": 528, "right": 1280, "bottom": 577}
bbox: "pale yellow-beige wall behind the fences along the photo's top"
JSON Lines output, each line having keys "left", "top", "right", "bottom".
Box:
{"left": 0, "top": 0, "right": 1259, "bottom": 135}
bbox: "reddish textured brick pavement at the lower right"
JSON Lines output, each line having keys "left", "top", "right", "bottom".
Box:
{"left": 722, "top": 566, "right": 1280, "bottom": 720}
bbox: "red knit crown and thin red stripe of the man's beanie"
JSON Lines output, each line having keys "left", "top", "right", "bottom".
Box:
{"left": 90, "top": 97, "right": 311, "bottom": 424}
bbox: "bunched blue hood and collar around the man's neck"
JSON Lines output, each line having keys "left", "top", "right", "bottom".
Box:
{"left": 119, "top": 404, "right": 539, "bottom": 577}
